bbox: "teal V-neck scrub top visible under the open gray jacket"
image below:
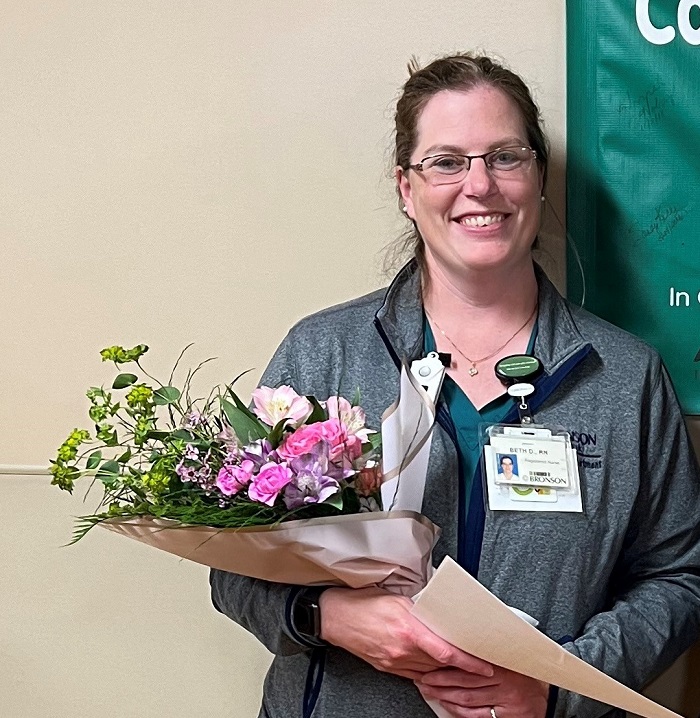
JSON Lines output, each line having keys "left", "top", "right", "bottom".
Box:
{"left": 423, "top": 315, "right": 537, "bottom": 516}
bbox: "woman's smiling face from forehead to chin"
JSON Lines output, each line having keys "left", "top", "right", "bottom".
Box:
{"left": 397, "top": 86, "right": 542, "bottom": 277}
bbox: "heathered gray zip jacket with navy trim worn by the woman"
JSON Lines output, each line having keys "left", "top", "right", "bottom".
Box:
{"left": 210, "top": 263, "right": 700, "bottom": 718}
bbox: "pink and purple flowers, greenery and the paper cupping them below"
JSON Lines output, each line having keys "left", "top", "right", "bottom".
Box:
{"left": 50, "top": 344, "right": 438, "bottom": 595}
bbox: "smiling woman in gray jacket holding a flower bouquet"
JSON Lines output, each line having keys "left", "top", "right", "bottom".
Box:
{"left": 211, "top": 55, "right": 700, "bottom": 718}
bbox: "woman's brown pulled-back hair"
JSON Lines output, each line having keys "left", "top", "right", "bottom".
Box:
{"left": 394, "top": 53, "right": 549, "bottom": 272}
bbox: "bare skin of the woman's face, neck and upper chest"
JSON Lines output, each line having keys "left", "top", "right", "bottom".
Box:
{"left": 396, "top": 86, "right": 542, "bottom": 405}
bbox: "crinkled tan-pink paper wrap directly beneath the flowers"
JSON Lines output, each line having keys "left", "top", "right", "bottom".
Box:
{"left": 100, "top": 511, "right": 440, "bottom": 596}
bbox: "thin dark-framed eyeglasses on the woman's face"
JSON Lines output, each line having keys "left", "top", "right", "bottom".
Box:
{"left": 408, "top": 147, "right": 537, "bottom": 185}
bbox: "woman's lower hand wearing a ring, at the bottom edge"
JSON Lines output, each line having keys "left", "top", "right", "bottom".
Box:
{"left": 416, "top": 666, "right": 549, "bottom": 718}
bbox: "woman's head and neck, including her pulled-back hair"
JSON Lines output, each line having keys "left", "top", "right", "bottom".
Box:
{"left": 395, "top": 57, "right": 549, "bottom": 407}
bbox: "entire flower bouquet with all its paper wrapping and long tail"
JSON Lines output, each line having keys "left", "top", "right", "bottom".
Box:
{"left": 51, "top": 344, "right": 679, "bottom": 718}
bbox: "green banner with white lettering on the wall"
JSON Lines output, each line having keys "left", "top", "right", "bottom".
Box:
{"left": 567, "top": 0, "right": 700, "bottom": 414}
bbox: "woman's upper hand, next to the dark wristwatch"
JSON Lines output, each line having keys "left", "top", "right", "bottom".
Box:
{"left": 319, "top": 588, "right": 493, "bottom": 680}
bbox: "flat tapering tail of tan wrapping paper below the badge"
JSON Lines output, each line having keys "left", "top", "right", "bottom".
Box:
{"left": 412, "top": 557, "right": 681, "bottom": 718}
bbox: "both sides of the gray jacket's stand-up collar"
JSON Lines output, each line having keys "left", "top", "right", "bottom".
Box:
{"left": 375, "top": 259, "right": 587, "bottom": 374}
